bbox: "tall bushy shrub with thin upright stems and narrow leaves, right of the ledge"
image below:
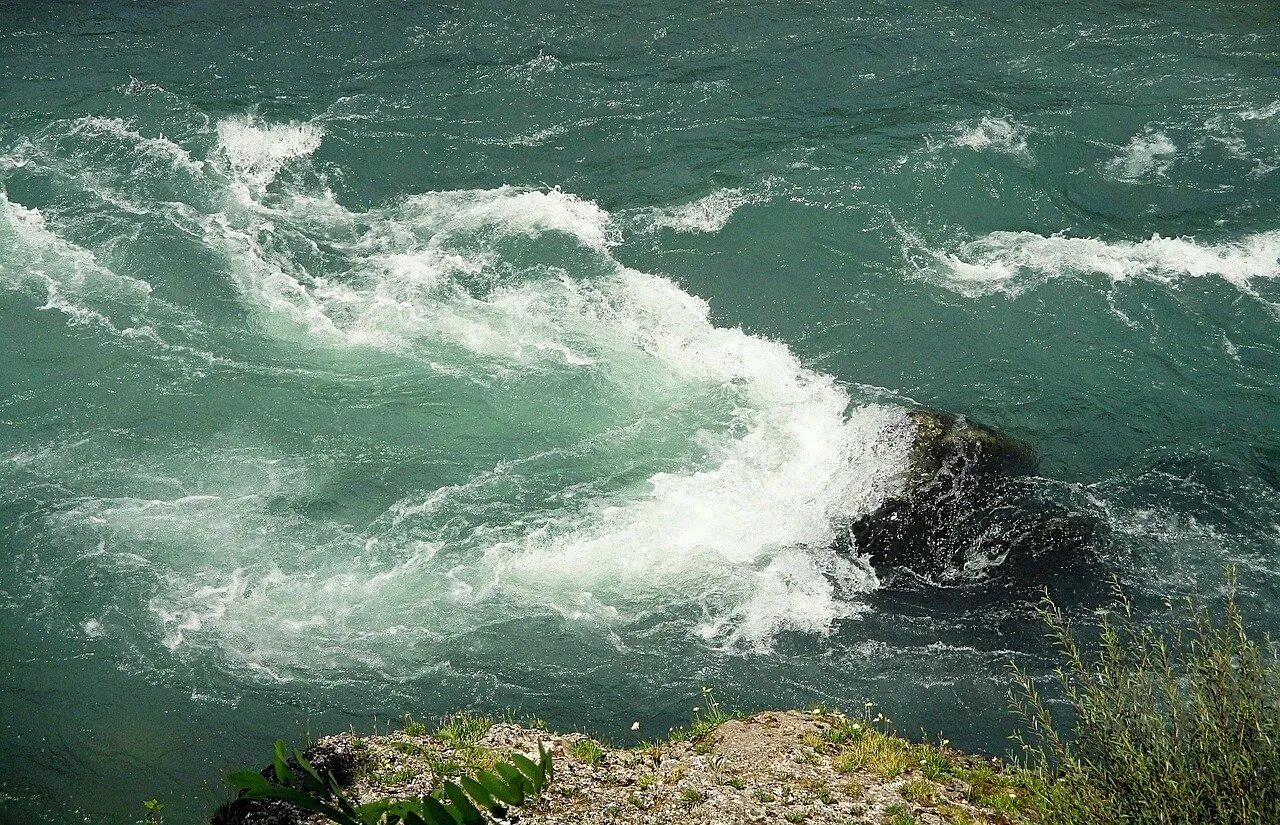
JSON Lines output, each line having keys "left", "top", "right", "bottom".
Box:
{"left": 1010, "top": 569, "right": 1280, "bottom": 825}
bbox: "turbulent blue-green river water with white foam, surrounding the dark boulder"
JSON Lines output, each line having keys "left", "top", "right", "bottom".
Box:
{"left": 0, "top": 0, "right": 1280, "bottom": 822}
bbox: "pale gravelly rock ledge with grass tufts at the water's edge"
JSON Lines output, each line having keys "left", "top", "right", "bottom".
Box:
{"left": 212, "top": 710, "right": 1025, "bottom": 825}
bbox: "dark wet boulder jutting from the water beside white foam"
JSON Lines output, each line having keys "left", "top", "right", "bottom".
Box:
{"left": 835, "top": 409, "right": 1098, "bottom": 581}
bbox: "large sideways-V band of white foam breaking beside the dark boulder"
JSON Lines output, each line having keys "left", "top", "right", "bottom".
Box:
{"left": 100, "top": 117, "right": 909, "bottom": 669}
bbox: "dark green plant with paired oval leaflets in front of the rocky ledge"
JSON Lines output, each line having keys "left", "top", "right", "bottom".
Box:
{"left": 227, "top": 741, "right": 554, "bottom": 825}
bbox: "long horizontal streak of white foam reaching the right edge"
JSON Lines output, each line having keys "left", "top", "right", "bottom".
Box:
{"left": 906, "top": 226, "right": 1280, "bottom": 297}
